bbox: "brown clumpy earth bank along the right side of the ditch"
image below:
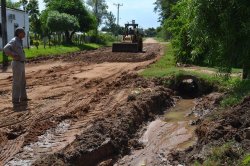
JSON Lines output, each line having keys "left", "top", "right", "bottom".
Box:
{"left": 168, "top": 93, "right": 250, "bottom": 165}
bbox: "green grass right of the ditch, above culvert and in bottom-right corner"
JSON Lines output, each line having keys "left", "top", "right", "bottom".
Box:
{"left": 141, "top": 43, "right": 250, "bottom": 166}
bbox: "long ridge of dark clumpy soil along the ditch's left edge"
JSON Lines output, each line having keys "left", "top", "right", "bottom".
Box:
{"left": 33, "top": 85, "right": 174, "bottom": 165}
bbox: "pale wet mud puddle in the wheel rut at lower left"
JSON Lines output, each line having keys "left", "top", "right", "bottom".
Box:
{"left": 5, "top": 120, "right": 77, "bottom": 166}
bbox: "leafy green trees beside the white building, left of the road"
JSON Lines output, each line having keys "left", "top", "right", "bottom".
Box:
{"left": 6, "top": 0, "right": 123, "bottom": 43}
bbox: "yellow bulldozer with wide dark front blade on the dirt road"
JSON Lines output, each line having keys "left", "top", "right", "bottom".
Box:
{"left": 112, "top": 20, "right": 143, "bottom": 52}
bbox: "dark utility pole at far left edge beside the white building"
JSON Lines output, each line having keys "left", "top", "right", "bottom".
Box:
{"left": 1, "top": 0, "right": 8, "bottom": 70}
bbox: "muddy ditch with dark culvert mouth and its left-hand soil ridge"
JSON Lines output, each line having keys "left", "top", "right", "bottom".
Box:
{"left": 23, "top": 76, "right": 216, "bottom": 166}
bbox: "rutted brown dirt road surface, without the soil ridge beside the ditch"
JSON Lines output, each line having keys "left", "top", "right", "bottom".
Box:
{"left": 0, "top": 44, "right": 165, "bottom": 165}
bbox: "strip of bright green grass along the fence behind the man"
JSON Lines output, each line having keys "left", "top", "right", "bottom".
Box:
{"left": 0, "top": 43, "right": 100, "bottom": 63}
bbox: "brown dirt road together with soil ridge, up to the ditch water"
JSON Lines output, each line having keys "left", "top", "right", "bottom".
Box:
{"left": 0, "top": 43, "right": 178, "bottom": 165}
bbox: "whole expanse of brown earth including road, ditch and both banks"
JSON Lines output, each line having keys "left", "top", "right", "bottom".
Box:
{"left": 0, "top": 40, "right": 244, "bottom": 166}
